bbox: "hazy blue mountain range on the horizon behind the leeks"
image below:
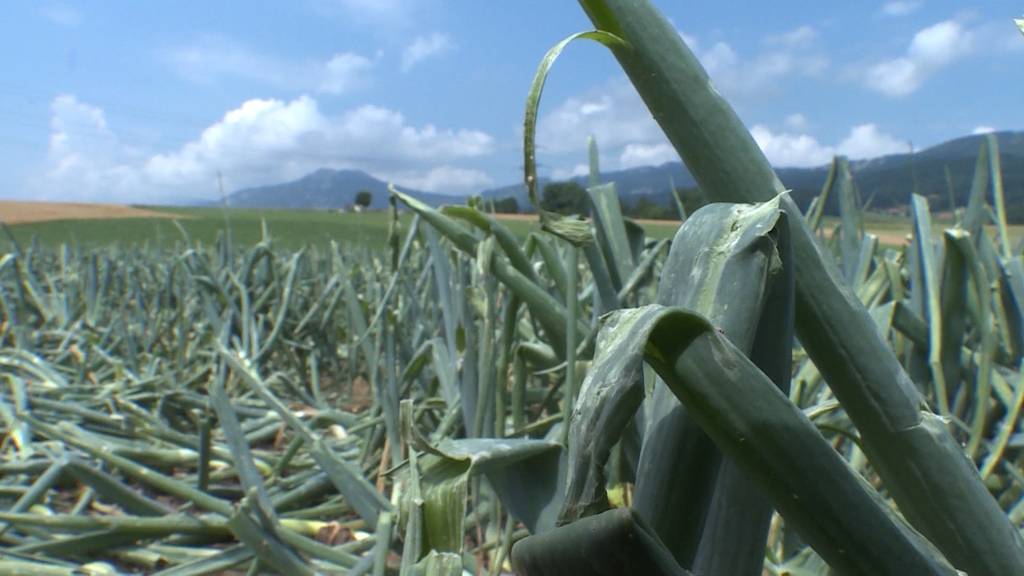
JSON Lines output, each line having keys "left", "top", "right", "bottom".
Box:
{"left": 227, "top": 131, "right": 1024, "bottom": 219}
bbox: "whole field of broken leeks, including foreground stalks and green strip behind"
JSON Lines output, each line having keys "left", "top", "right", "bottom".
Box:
{"left": 0, "top": 0, "right": 1024, "bottom": 576}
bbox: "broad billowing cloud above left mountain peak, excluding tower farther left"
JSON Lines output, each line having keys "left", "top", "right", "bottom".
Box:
{"left": 145, "top": 96, "right": 493, "bottom": 192}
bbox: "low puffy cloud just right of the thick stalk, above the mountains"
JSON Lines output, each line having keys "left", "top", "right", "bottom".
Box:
{"left": 751, "top": 124, "right": 907, "bottom": 167}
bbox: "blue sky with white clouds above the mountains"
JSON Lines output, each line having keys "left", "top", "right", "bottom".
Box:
{"left": 0, "top": 0, "right": 1024, "bottom": 202}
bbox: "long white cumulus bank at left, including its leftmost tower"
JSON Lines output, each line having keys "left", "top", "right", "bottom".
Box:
{"left": 36, "top": 95, "right": 494, "bottom": 201}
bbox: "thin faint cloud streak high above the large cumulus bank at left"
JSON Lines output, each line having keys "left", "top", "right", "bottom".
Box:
{"left": 162, "top": 36, "right": 374, "bottom": 94}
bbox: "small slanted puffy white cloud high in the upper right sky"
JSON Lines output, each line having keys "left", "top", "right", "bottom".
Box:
{"left": 864, "top": 20, "right": 974, "bottom": 96}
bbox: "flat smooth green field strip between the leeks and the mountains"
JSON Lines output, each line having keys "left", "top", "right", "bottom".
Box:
{"left": 0, "top": 206, "right": 678, "bottom": 249}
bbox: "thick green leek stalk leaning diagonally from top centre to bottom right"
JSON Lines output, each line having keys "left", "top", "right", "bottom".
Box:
{"left": 580, "top": 0, "right": 1024, "bottom": 576}
